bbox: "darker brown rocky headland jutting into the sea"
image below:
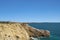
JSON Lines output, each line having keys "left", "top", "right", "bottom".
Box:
{"left": 21, "top": 23, "right": 50, "bottom": 37}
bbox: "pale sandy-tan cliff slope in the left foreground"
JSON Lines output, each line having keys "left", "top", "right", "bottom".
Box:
{"left": 0, "top": 23, "right": 29, "bottom": 40}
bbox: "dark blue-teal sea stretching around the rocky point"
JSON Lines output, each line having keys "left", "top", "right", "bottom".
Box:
{"left": 29, "top": 22, "right": 60, "bottom": 40}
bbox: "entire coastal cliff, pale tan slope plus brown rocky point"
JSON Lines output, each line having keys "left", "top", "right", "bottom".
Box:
{"left": 0, "top": 22, "right": 50, "bottom": 40}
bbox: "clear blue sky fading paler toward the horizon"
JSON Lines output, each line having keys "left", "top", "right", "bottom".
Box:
{"left": 0, "top": 0, "right": 60, "bottom": 22}
